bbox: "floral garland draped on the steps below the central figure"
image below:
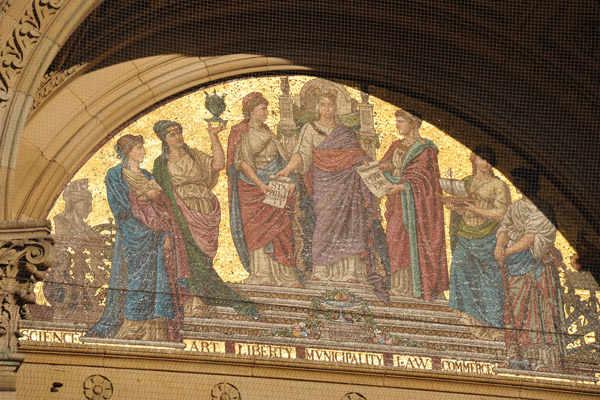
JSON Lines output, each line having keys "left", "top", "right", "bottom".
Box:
{"left": 265, "top": 289, "right": 420, "bottom": 347}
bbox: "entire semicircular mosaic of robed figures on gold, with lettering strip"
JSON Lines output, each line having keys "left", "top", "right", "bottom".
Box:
{"left": 23, "top": 76, "right": 599, "bottom": 382}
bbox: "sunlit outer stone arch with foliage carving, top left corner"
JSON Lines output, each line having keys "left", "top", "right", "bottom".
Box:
{"left": 0, "top": 0, "right": 102, "bottom": 219}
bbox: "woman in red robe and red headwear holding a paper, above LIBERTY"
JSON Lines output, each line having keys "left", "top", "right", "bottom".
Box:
{"left": 227, "top": 92, "right": 303, "bottom": 287}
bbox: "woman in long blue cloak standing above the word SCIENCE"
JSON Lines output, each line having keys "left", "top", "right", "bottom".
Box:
{"left": 86, "top": 135, "right": 190, "bottom": 342}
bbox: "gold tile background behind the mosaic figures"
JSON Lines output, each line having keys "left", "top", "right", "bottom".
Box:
{"left": 47, "top": 76, "right": 574, "bottom": 284}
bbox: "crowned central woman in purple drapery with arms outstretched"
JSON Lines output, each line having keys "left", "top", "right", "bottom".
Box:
{"left": 277, "top": 87, "right": 387, "bottom": 299}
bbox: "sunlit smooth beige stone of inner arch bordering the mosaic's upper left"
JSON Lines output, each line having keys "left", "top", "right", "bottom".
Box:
{"left": 15, "top": 54, "right": 305, "bottom": 219}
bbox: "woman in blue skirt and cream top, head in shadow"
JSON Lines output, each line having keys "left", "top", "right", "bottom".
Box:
{"left": 446, "top": 146, "right": 510, "bottom": 328}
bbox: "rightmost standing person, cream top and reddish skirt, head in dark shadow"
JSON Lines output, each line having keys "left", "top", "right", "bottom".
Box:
{"left": 494, "top": 167, "right": 566, "bottom": 372}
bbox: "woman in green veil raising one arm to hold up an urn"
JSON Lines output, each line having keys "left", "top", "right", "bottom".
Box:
{"left": 153, "top": 120, "right": 258, "bottom": 318}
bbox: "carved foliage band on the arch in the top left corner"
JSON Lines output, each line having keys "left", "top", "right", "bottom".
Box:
{"left": 0, "top": 0, "right": 66, "bottom": 104}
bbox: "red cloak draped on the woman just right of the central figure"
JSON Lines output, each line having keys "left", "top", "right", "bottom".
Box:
{"left": 382, "top": 139, "right": 449, "bottom": 301}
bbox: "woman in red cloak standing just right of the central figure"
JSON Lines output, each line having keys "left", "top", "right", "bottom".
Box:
{"left": 379, "top": 110, "right": 448, "bottom": 301}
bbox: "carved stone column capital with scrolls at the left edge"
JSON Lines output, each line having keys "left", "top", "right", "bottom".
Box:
{"left": 0, "top": 221, "right": 55, "bottom": 359}
